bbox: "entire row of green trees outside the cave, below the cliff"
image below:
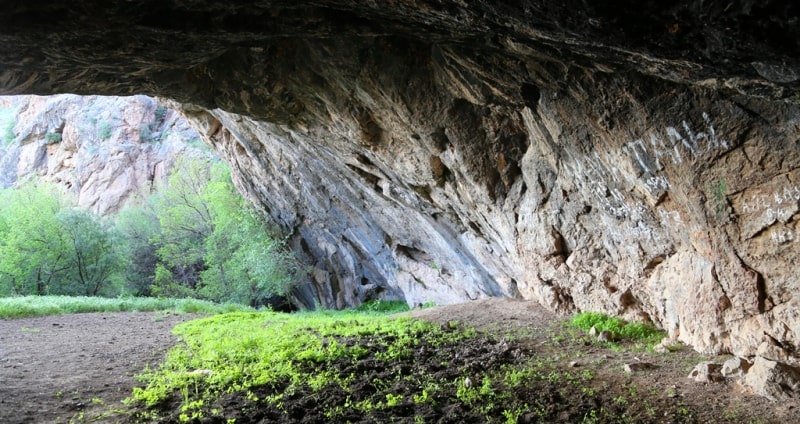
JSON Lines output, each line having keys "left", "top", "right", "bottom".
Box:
{"left": 0, "top": 154, "right": 297, "bottom": 306}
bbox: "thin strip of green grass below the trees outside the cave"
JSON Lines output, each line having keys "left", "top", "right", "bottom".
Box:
{"left": 0, "top": 296, "right": 252, "bottom": 319}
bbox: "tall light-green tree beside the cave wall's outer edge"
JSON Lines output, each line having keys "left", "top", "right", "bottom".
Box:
{"left": 145, "top": 159, "right": 296, "bottom": 306}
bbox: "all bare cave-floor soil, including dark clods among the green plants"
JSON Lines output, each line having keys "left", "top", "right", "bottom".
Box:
{"left": 0, "top": 299, "right": 800, "bottom": 423}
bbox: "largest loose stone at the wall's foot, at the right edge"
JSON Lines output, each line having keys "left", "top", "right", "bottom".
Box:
{"left": 742, "top": 356, "right": 800, "bottom": 401}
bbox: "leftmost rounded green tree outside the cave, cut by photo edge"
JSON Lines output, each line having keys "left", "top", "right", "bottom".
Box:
{"left": 0, "top": 181, "right": 126, "bottom": 296}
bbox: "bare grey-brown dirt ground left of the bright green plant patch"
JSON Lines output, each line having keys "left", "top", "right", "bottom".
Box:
{"left": 0, "top": 312, "right": 197, "bottom": 424}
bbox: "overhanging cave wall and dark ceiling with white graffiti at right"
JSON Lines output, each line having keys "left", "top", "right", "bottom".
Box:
{"left": 0, "top": 0, "right": 800, "bottom": 368}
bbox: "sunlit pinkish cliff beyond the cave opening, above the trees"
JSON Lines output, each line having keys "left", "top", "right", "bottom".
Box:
{"left": 0, "top": 95, "right": 205, "bottom": 215}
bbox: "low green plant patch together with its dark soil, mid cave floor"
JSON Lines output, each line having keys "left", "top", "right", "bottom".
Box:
{"left": 128, "top": 305, "right": 576, "bottom": 422}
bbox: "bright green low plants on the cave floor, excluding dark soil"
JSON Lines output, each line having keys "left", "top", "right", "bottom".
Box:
{"left": 129, "top": 302, "right": 476, "bottom": 420}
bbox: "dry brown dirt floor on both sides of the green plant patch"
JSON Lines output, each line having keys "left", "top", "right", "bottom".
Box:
{"left": 0, "top": 299, "right": 800, "bottom": 424}
